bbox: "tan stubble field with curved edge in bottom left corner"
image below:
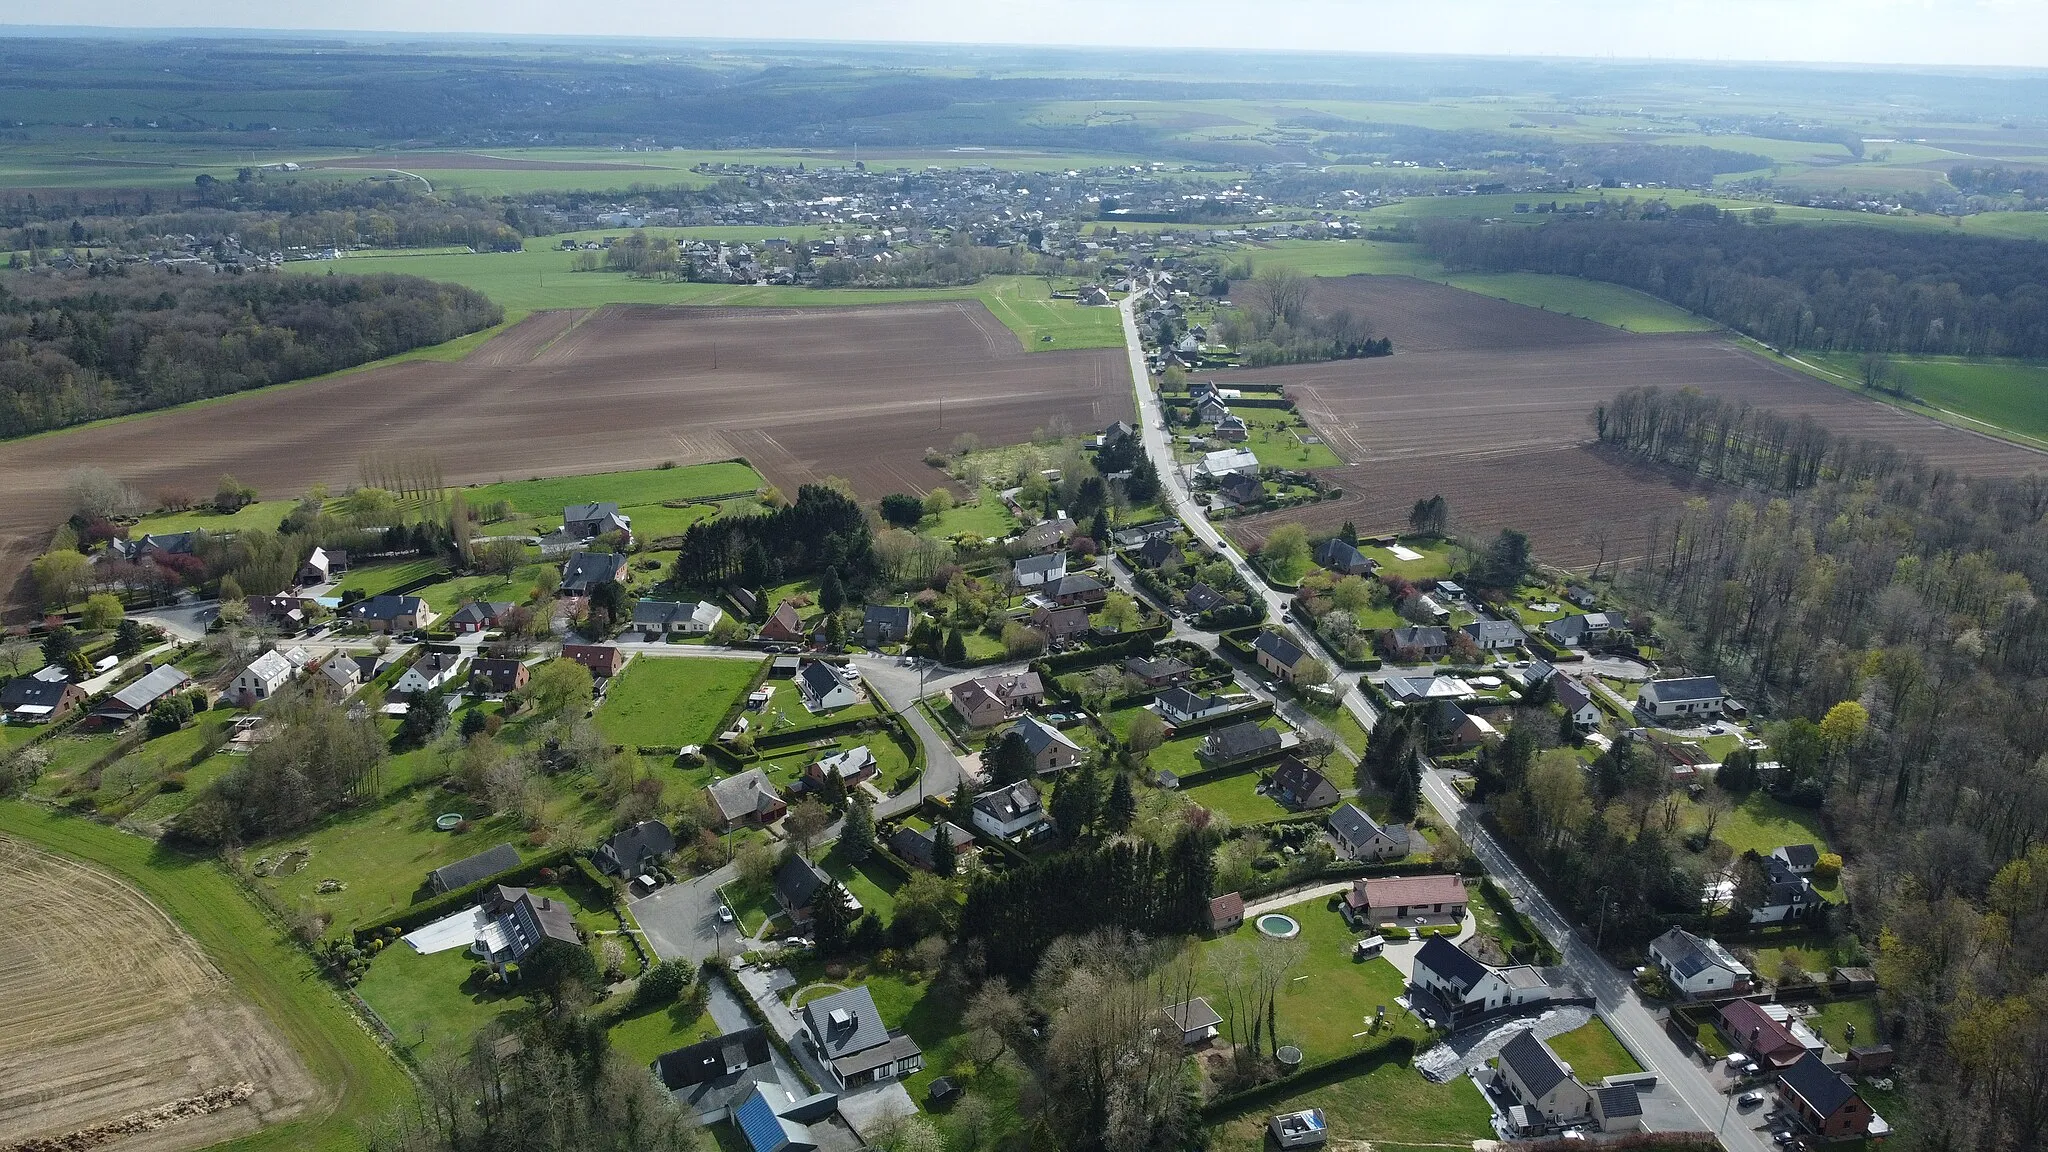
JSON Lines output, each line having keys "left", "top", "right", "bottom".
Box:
{"left": 0, "top": 836, "right": 319, "bottom": 1152}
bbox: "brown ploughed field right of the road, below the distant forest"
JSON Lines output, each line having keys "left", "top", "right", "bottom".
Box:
{"left": 1212, "top": 277, "right": 2048, "bottom": 566}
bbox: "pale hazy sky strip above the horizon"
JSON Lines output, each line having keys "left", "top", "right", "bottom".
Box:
{"left": 12, "top": 0, "right": 2048, "bottom": 68}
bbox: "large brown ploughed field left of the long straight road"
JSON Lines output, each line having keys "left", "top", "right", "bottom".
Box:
{"left": 0, "top": 301, "right": 1133, "bottom": 602}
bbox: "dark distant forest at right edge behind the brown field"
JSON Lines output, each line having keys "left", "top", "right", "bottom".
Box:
{"left": 1417, "top": 201, "right": 2048, "bottom": 357}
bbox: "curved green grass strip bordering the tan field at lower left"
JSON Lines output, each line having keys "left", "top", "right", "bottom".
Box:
{"left": 0, "top": 801, "right": 412, "bottom": 1152}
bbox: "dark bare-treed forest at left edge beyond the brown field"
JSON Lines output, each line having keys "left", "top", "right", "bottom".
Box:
{"left": 0, "top": 264, "right": 504, "bottom": 437}
